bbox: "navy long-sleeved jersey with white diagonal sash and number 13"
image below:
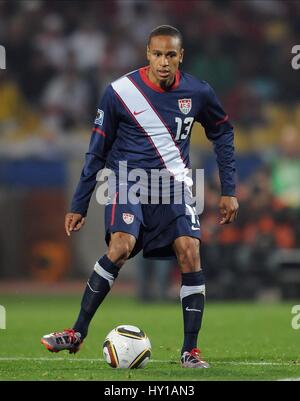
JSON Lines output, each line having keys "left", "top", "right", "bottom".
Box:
{"left": 71, "top": 67, "right": 235, "bottom": 216}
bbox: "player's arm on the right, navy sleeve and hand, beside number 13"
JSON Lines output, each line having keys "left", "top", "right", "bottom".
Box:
{"left": 197, "top": 85, "right": 239, "bottom": 224}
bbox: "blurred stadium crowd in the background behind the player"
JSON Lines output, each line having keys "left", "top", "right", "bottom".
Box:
{"left": 0, "top": 0, "right": 300, "bottom": 296}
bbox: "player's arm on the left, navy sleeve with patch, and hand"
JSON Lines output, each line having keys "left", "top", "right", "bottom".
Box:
{"left": 65, "top": 85, "right": 118, "bottom": 236}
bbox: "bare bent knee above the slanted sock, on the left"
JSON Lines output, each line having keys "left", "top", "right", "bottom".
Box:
{"left": 107, "top": 233, "right": 135, "bottom": 267}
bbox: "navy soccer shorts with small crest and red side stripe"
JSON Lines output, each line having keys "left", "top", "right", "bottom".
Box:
{"left": 105, "top": 191, "right": 200, "bottom": 259}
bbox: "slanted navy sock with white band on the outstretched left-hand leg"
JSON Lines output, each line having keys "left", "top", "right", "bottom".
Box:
{"left": 73, "top": 255, "right": 119, "bottom": 339}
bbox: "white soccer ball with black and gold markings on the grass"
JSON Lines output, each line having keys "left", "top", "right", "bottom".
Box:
{"left": 103, "top": 325, "right": 151, "bottom": 369}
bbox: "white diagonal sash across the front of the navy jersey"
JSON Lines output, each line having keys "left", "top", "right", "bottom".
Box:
{"left": 112, "top": 76, "right": 191, "bottom": 186}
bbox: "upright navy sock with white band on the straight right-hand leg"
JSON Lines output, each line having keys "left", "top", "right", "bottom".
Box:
{"left": 180, "top": 270, "right": 205, "bottom": 353}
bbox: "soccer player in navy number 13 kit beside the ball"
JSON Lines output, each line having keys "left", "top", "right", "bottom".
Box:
{"left": 41, "top": 25, "right": 238, "bottom": 368}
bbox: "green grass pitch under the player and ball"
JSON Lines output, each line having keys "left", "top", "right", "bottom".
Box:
{"left": 0, "top": 294, "right": 300, "bottom": 381}
